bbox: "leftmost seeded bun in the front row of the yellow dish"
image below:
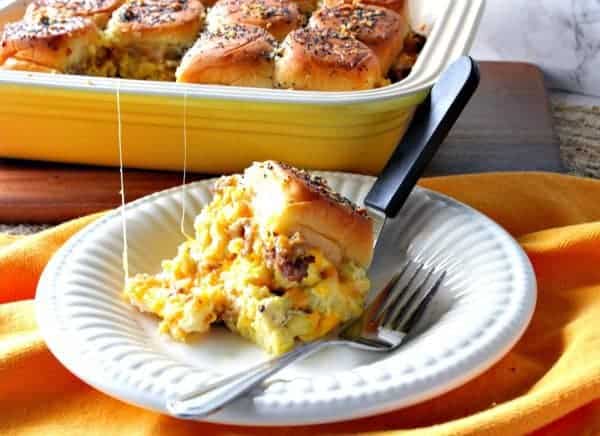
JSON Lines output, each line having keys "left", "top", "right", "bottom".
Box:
{"left": 0, "top": 17, "right": 100, "bottom": 73}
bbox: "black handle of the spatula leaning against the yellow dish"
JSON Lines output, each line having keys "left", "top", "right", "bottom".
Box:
{"left": 365, "top": 56, "right": 479, "bottom": 218}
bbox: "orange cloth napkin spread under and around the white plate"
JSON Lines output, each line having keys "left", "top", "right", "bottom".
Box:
{"left": 0, "top": 173, "right": 600, "bottom": 436}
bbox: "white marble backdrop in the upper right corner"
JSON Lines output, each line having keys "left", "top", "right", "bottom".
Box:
{"left": 473, "top": 0, "right": 600, "bottom": 97}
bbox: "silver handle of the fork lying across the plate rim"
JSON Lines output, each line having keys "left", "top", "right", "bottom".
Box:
{"left": 167, "top": 340, "right": 338, "bottom": 419}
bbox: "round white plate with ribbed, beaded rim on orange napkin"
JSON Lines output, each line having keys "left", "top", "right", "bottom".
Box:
{"left": 36, "top": 173, "right": 536, "bottom": 425}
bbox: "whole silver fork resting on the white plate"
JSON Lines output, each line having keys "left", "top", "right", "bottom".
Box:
{"left": 167, "top": 260, "right": 446, "bottom": 419}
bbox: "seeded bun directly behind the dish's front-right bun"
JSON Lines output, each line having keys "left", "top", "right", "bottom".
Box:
{"left": 309, "top": 4, "right": 409, "bottom": 74}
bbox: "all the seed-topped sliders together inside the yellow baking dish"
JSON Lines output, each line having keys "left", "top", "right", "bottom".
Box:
{"left": 0, "top": 0, "right": 422, "bottom": 91}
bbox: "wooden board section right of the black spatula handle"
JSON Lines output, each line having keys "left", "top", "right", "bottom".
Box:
{"left": 428, "top": 62, "right": 564, "bottom": 175}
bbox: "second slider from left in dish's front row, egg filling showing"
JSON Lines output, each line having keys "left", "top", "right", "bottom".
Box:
{"left": 106, "top": 0, "right": 204, "bottom": 80}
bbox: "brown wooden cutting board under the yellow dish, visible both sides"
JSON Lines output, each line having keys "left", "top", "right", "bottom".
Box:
{"left": 0, "top": 62, "right": 563, "bottom": 223}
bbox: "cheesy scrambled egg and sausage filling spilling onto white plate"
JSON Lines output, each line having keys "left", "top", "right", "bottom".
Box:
{"left": 124, "top": 176, "right": 369, "bottom": 354}
